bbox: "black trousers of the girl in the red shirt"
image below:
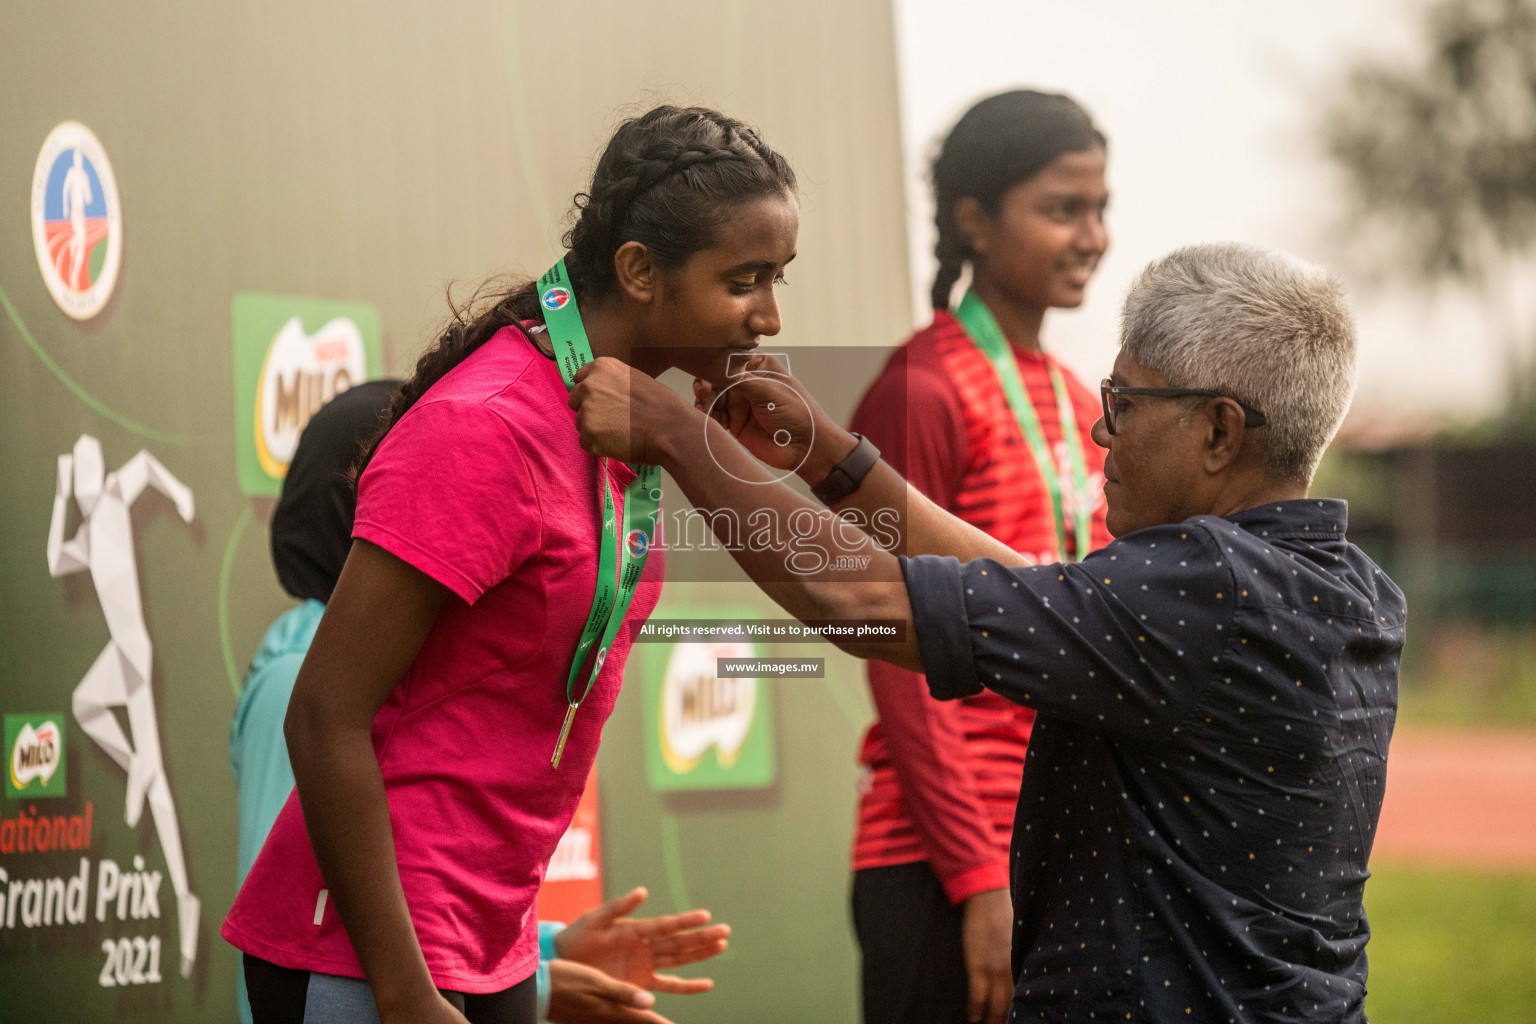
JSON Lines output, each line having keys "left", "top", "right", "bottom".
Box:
{"left": 854, "top": 863, "right": 969, "bottom": 1024}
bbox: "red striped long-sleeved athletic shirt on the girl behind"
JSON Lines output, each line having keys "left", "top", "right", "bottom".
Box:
{"left": 852, "top": 312, "right": 1109, "bottom": 903}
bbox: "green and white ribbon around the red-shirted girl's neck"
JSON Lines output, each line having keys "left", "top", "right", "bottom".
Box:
{"left": 955, "top": 289, "right": 1094, "bottom": 560}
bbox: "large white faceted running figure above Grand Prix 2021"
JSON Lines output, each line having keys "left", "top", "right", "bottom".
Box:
{"left": 48, "top": 434, "right": 200, "bottom": 978}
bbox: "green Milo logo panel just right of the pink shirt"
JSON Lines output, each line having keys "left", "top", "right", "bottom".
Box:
{"left": 630, "top": 608, "right": 776, "bottom": 792}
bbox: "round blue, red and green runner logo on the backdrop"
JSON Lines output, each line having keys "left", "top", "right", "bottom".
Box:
{"left": 32, "top": 121, "right": 123, "bottom": 319}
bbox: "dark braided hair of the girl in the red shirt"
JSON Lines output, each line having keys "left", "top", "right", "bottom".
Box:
{"left": 929, "top": 89, "right": 1107, "bottom": 310}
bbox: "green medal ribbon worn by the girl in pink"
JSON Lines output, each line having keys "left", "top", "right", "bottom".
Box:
{"left": 539, "top": 258, "right": 660, "bottom": 769}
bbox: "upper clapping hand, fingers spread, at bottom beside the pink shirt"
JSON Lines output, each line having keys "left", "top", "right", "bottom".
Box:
{"left": 554, "top": 887, "right": 731, "bottom": 995}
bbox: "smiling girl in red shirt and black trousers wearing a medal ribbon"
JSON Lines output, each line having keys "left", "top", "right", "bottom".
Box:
{"left": 852, "top": 91, "right": 1109, "bottom": 1024}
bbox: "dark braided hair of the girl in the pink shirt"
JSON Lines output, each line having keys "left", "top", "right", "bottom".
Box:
{"left": 356, "top": 106, "right": 796, "bottom": 477}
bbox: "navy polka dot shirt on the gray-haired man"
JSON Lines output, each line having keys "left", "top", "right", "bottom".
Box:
{"left": 903, "top": 499, "right": 1405, "bottom": 1024}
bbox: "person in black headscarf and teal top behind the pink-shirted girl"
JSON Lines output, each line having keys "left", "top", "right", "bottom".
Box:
{"left": 229, "top": 381, "right": 731, "bottom": 1024}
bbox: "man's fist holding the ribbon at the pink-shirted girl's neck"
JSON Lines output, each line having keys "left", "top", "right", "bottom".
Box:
{"left": 568, "top": 356, "right": 702, "bottom": 465}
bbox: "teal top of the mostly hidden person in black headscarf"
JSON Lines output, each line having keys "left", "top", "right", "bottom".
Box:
{"left": 229, "top": 600, "right": 564, "bottom": 1024}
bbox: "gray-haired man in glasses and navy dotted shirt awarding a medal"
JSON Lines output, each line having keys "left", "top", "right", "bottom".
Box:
{"left": 571, "top": 246, "right": 1405, "bottom": 1022}
